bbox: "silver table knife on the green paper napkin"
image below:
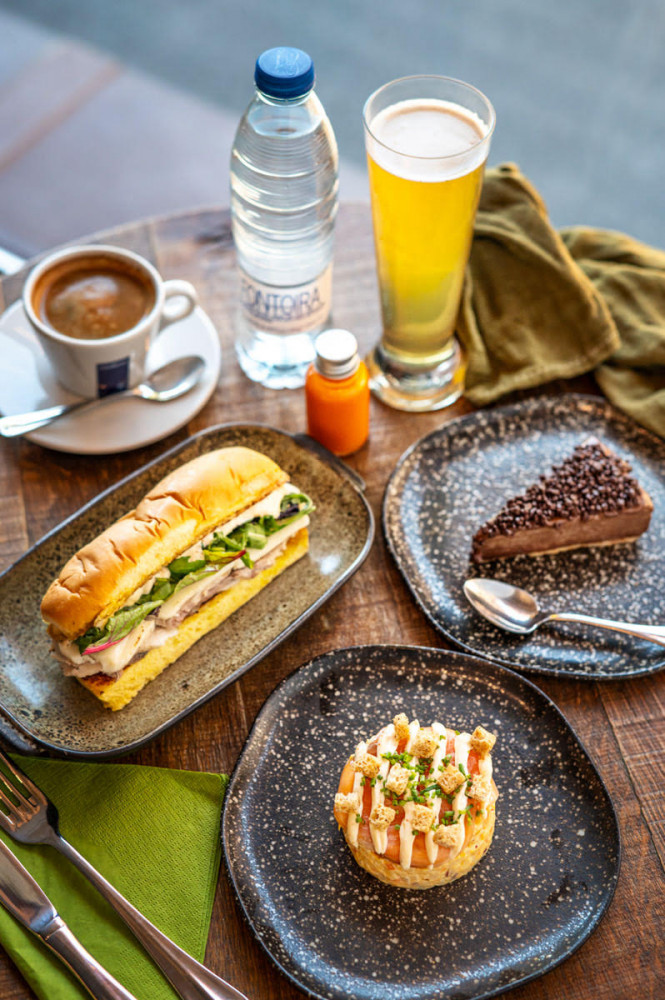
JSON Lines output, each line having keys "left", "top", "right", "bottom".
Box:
{"left": 0, "top": 840, "right": 136, "bottom": 1000}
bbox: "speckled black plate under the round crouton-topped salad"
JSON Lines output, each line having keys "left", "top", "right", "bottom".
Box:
{"left": 222, "top": 646, "right": 620, "bottom": 1000}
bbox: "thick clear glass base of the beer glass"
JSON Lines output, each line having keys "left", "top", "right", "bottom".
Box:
{"left": 366, "top": 341, "right": 465, "bottom": 413}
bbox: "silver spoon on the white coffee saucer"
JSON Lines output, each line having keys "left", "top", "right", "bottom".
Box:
{"left": 0, "top": 354, "right": 205, "bottom": 437}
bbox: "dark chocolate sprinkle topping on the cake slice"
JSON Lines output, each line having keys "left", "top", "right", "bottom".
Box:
{"left": 473, "top": 438, "right": 641, "bottom": 548}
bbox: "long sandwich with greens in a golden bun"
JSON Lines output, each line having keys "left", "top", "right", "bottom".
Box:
{"left": 41, "top": 447, "right": 314, "bottom": 711}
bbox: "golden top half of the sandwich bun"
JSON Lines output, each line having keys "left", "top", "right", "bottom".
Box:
{"left": 41, "top": 447, "right": 289, "bottom": 641}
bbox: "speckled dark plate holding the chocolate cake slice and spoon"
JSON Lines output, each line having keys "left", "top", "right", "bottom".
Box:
{"left": 383, "top": 395, "right": 665, "bottom": 680}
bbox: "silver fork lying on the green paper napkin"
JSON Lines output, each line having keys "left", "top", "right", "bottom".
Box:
{"left": 0, "top": 751, "right": 247, "bottom": 1000}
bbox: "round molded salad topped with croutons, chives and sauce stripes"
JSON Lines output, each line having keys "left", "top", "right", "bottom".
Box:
{"left": 334, "top": 714, "right": 498, "bottom": 889}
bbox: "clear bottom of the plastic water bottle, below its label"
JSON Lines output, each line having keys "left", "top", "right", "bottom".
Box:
{"left": 235, "top": 330, "right": 315, "bottom": 389}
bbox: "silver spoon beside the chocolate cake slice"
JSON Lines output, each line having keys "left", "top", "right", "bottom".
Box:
{"left": 464, "top": 577, "right": 665, "bottom": 646}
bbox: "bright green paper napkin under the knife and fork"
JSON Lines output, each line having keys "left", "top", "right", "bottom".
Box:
{"left": 0, "top": 756, "right": 227, "bottom": 1000}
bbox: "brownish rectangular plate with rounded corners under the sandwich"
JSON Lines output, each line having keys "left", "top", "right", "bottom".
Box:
{"left": 0, "top": 424, "right": 374, "bottom": 759}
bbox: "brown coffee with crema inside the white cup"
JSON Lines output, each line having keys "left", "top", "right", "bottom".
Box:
{"left": 33, "top": 256, "right": 155, "bottom": 340}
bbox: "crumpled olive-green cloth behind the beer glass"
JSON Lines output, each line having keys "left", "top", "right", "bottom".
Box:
{"left": 457, "top": 164, "right": 665, "bottom": 436}
